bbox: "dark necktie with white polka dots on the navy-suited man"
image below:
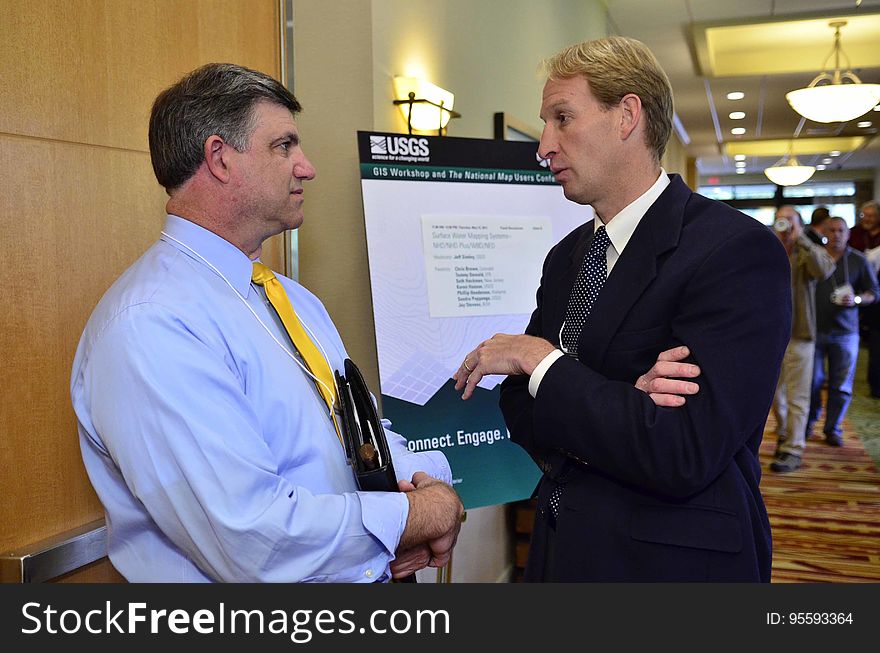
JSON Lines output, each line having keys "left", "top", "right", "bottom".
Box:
{"left": 550, "top": 225, "right": 611, "bottom": 522}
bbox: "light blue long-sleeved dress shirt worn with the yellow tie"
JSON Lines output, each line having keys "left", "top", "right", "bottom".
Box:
{"left": 71, "top": 215, "right": 452, "bottom": 582}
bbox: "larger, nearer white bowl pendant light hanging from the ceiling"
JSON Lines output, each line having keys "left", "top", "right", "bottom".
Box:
{"left": 785, "top": 20, "right": 880, "bottom": 122}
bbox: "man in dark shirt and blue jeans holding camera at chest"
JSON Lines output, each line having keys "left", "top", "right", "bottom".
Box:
{"left": 806, "top": 217, "right": 880, "bottom": 447}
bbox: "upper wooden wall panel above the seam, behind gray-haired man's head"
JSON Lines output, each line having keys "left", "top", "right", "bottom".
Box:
{"left": 0, "top": 0, "right": 280, "bottom": 152}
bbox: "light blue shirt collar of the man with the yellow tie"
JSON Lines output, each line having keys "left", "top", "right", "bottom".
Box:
{"left": 161, "top": 214, "right": 253, "bottom": 296}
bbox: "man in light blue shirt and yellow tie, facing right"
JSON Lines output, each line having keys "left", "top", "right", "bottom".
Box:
{"left": 71, "top": 64, "right": 462, "bottom": 582}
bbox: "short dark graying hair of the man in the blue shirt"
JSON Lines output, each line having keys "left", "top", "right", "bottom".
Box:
{"left": 150, "top": 63, "right": 302, "bottom": 194}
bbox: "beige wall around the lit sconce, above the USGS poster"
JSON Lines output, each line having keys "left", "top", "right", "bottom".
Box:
{"left": 373, "top": 0, "right": 607, "bottom": 138}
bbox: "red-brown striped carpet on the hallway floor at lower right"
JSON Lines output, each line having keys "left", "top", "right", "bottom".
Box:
{"left": 761, "top": 408, "right": 880, "bottom": 583}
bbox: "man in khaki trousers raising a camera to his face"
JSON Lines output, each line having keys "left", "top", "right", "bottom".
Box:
{"left": 770, "top": 205, "right": 834, "bottom": 472}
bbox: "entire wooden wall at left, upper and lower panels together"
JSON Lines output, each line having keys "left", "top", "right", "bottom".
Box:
{"left": 0, "top": 0, "right": 283, "bottom": 579}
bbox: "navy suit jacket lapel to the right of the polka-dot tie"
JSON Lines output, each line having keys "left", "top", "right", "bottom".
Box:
{"left": 576, "top": 175, "right": 692, "bottom": 370}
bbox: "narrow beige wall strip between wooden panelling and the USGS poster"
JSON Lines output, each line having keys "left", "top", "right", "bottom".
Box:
{"left": 293, "top": 0, "right": 379, "bottom": 394}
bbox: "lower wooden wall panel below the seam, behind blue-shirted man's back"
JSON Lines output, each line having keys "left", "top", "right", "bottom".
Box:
{"left": 0, "top": 136, "right": 165, "bottom": 551}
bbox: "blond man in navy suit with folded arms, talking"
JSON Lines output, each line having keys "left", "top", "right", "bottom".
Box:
{"left": 455, "top": 37, "right": 791, "bottom": 582}
